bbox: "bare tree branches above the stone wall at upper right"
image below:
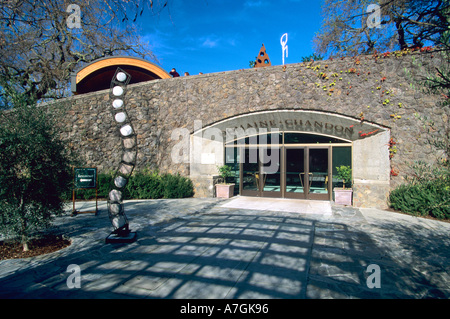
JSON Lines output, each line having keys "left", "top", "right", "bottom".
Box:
{"left": 314, "top": 0, "right": 450, "bottom": 56}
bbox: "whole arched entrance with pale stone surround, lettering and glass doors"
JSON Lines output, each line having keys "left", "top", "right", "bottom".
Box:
{"left": 190, "top": 110, "right": 390, "bottom": 206}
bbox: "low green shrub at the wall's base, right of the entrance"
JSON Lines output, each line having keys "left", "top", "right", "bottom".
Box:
{"left": 389, "top": 178, "right": 450, "bottom": 219}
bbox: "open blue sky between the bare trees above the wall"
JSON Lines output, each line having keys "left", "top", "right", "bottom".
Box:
{"left": 140, "top": 0, "right": 322, "bottom": 75}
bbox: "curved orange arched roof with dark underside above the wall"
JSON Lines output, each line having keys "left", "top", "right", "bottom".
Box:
{"left": 72, "top": 56, "right": 172, "bottom": 94}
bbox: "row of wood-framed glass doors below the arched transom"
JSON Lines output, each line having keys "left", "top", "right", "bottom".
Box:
{"left": 239, "top": 141, "right": 334, "bottom": 200}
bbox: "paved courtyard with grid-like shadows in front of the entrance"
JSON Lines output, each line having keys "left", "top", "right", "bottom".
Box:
{"left": 0, "top": 197, "right": 450, "bottom": 299}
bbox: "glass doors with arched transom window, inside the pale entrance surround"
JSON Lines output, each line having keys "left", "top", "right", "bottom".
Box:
{"left": 225, "top": 131, "right": 352, "bottom": 200}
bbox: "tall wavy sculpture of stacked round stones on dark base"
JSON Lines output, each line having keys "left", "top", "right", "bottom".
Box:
{"left": 106, "top": 68, "right": 137, "bottom": 243}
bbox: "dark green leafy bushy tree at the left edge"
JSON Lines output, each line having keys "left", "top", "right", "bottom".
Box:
{"left": 0, "top": 101, "right": 75, "bottom": 250}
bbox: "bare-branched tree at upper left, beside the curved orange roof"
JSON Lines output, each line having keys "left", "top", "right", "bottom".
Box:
{"left": 0, "top": 0, "right": 171, "bottom": 100}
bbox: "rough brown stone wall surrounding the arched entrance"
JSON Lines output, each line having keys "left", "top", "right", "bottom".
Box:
{"left": 48, "top": 51, "right": 448, "bottom": 208}
